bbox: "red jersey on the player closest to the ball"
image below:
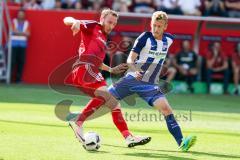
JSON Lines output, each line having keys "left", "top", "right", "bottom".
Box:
{"left": 75, "top": 20, "right": 107, "bottom": 68}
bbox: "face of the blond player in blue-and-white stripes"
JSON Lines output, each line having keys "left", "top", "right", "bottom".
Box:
{"left": 151, "top": 20, "right": 167, "bottom": 38}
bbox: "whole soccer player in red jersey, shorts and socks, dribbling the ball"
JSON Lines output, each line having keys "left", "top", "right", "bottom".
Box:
{"left": 64, "top": 9, "right": 151, "bottom": 147}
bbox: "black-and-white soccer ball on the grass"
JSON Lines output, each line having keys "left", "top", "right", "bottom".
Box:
{"left": 83, "top": 132, "right": 100, "bottom": 151}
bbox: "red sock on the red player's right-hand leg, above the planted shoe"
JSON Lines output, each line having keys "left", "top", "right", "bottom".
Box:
{"left": 112, "top": 108, "right": 132, "bottom": 138}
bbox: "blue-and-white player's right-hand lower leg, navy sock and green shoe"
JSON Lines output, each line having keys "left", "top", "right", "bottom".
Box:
{"left": 153, "top": 97, "right": 196, "bottom": 151}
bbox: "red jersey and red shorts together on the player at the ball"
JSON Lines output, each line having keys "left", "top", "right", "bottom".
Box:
{"left": 66, "top": 21, "right": 107, "bottom": 97}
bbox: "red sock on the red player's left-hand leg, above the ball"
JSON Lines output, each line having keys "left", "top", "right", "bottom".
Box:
{"left": 76, "top": 97, "right": 105, "bottom": 126}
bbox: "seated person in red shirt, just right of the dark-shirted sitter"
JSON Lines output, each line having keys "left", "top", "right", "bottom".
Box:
{"left": 206, "top": 42, "right": 229, "bottom": 94}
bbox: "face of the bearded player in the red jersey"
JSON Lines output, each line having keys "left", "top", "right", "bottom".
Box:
{"left": 102, "top": 14, "right": 117, "bottom": 34}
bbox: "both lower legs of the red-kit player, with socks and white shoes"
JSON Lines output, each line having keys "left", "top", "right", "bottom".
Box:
{"left": 69, "top": 86, "right": 151, "bottom": 147}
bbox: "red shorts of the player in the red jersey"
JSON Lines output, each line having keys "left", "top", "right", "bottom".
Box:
{"left": 67, "top": 64, "right": 107, "bottom": 97}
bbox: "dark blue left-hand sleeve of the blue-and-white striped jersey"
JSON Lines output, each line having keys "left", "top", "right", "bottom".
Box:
{"left": 132, "top": 32, "right": 148, "bottom": 54}
